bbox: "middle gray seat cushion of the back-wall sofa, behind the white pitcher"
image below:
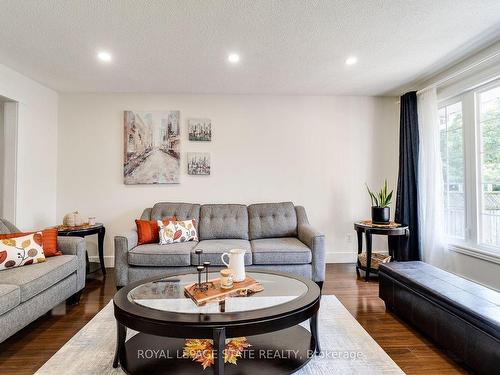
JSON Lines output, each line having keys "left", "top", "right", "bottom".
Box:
{"left": 191, "top": 239, "right": 252, "bottom": 266}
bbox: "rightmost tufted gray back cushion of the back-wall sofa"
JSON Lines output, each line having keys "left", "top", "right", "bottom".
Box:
{"left": 248, "top": 202, "right": 297, "bottom": 240}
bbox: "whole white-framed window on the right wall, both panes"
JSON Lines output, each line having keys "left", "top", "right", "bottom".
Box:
{"left": 439, "top": 81, "right": 500, "bottom": 256}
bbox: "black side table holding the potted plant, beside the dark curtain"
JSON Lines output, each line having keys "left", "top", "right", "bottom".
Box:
{"left": 354, "top": 221, "right": 410, "bottom": 281}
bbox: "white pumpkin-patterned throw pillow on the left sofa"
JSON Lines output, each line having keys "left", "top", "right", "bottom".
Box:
{"left": 0, "top": 232, "right": 45, "bottom": 270}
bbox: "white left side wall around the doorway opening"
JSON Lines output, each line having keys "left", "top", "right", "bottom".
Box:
{"left": 0, "top": 65, "right": 58, "bottom": 230}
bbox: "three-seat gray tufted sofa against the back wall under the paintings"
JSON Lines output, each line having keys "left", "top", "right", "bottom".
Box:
{"left": 115, "top": 202, "right": 325, "bottom": 287}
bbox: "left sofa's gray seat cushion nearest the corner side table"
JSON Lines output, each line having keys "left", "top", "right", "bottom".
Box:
{"left": 0, "top": 255, "right": 78, "bottom": 302}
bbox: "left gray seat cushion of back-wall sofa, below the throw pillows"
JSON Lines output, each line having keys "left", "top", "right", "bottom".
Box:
{"left": 128, "top": 241, "right": 198, "bottom": 267}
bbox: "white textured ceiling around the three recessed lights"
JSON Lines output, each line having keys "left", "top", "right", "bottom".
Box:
{"left": 0, "top": 0, "right": 500, "bottom": 95}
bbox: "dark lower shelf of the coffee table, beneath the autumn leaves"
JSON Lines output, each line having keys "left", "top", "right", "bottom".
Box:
{"left": 120, "top": 325, "right": 315, "bottom": 375}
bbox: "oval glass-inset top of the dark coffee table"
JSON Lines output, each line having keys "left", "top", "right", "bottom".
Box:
{"left": 113, "top": 271, "right": 320, "bottom": 337}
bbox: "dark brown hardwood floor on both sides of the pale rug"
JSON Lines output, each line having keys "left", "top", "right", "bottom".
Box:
{"left": 0, "top": 264, "right": 467, "bottom": 375}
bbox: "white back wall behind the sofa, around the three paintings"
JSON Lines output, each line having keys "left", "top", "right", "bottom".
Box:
{"left": 57, "top": 94, "right": 398, "bottom": 264}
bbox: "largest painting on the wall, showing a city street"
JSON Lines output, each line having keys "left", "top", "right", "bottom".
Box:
{"left": 123, "top": 111, "right": 180, "bottom": 185}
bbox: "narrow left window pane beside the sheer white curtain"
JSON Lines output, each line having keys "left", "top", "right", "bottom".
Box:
{"left": 439, "top": 102, "right": 465, "bottom": 239}
